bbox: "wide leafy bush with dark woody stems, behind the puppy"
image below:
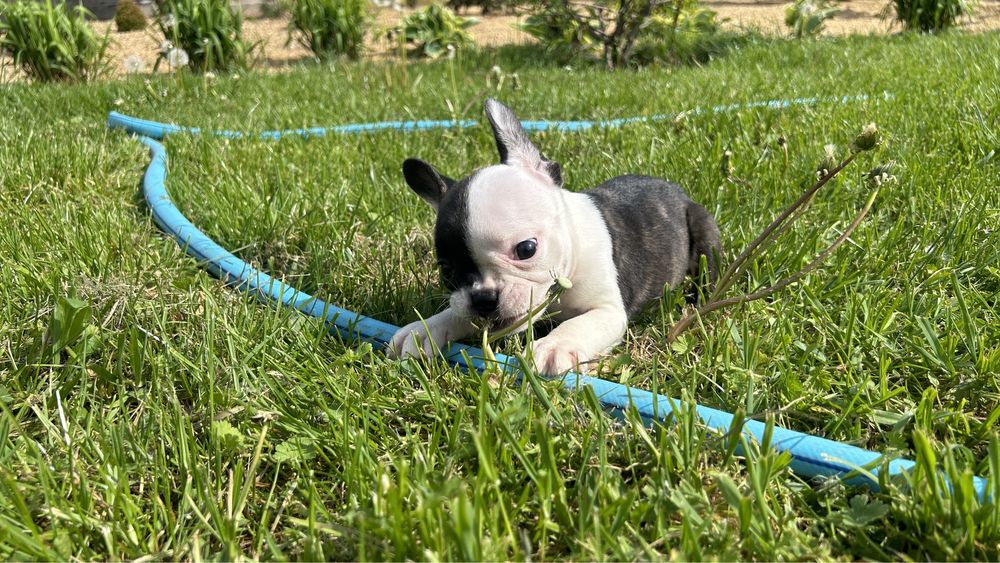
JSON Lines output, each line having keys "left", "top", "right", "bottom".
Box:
{"left": 520, "top": 0, "right": 718, "bottom": 68}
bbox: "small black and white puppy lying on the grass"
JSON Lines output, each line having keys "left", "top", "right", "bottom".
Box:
{"left": 388, "top": 99, "right": 720, "bottom": 375}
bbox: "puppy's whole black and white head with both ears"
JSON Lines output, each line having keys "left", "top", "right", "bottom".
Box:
{"left": 403, "top": 99, "right": 574, "bottom": 326}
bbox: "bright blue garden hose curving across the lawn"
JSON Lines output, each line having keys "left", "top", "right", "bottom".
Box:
{"left": 108, "top": 94, "right": 996, "bottom": 502}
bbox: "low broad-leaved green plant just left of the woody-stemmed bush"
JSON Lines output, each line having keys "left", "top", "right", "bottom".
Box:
{"left": 389, "top": 4, "right": 478, "bottom": 59}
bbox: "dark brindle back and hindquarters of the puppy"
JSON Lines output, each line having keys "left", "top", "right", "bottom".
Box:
{"left": 585, "top": 175, "right": 721, "bottom": 317}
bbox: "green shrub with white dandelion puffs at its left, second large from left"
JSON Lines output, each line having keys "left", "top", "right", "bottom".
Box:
{"left": 156, "top": 0, "right": 257, "bottom": 72}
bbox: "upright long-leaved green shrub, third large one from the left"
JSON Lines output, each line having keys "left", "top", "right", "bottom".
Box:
{"left": 289, "top": 0, "right": 368, "bottom": 59}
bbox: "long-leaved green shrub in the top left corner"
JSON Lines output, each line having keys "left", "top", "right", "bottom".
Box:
{"left": 0, "top": 0, "right": 110, "bottom": 81}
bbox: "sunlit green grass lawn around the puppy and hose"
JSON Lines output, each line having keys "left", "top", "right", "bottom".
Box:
{"left": 0, "top": 34, "right": 1000, "bottom": 560}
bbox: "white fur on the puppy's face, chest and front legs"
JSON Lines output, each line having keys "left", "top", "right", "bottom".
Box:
{"left": 389, "top": 163, "right": 627, "bottom": 375}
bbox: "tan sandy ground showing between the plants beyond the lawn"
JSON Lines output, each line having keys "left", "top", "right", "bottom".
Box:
{"left": 0, "top": 0, "right": 1000, "bottom": 83}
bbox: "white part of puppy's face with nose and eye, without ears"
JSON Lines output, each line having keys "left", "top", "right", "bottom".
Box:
{"left": 446, "top": 164, "right": 573, "bottom": 325}
